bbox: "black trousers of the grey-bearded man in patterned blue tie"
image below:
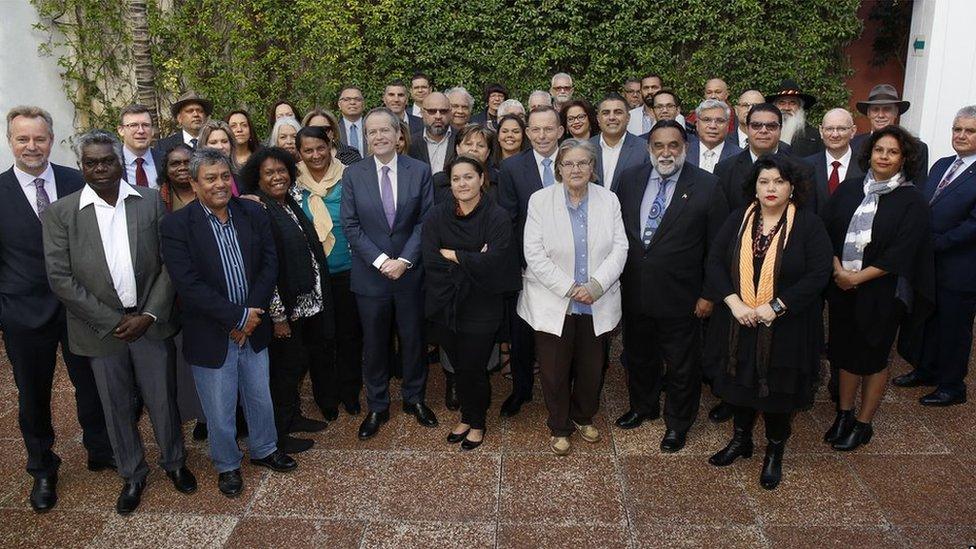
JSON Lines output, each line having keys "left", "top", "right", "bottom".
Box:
{"left": 623, "top": 311, "right": 702, "bottom": 431}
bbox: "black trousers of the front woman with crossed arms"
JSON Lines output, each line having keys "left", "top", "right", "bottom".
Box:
{"left": 440, "top": 330, "right": 495, "bottom": 429}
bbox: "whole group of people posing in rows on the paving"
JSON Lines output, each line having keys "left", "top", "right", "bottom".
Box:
{"left": 0, "top": 69, "right": 976, "bottom": 514}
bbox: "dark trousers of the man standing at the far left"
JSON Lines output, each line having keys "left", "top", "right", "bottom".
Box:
{"left": 3, "top": 316, "right": 112, "bottom": 478}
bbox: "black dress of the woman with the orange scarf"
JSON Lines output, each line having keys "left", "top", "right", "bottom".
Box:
{"left": 704, "top": 208, "right": 831, "bottom": 413}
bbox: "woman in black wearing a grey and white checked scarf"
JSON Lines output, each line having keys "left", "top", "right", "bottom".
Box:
{"left": 822, "top": 126, "right": 932, "bottom": 451}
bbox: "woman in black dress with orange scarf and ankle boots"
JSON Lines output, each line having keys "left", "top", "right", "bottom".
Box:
{"left": 705, "top": 156, "right": 831, "bottom": 490}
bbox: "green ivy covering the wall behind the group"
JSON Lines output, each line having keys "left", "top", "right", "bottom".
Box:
{"left": 32, "top": 0, "right": 861, "bottom": 136}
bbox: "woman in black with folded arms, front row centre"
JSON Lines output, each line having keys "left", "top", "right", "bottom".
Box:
{"left": 422, "top": 156, "right": 521, "bottom": 450}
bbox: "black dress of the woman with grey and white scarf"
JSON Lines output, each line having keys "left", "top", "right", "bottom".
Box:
{"left": 822, "top": 177, "right": 931, "bottom": 375}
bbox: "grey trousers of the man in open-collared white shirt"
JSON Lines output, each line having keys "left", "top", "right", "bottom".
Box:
{"left": 91, "top": 337, "right": 186, "bottom": 482}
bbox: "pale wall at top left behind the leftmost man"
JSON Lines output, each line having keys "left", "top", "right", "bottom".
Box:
{"left": 0, "top": 0, "right": 77, "bottom": 170}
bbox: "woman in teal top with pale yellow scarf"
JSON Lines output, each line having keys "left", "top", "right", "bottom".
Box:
{"left": 293, "top": 126, "right": 363, "bottom": 421}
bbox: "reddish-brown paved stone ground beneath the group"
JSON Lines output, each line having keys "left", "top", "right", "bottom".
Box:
{"left": 0, "top": 334, "right": 976, "bottom": 549}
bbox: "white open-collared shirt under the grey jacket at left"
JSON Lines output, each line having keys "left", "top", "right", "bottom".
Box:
{"left": 78, "top": 181, "right": 142, "bottom": 308}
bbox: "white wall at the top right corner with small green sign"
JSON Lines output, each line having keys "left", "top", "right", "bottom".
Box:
{"left": 901, "top": 0, "right": 976, "bottom": 163}
